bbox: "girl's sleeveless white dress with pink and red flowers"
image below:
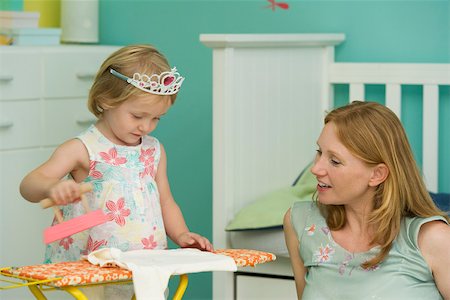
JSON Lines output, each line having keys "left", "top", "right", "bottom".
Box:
{"left": 45, "top": 125, "right": 167, "bottom": 263}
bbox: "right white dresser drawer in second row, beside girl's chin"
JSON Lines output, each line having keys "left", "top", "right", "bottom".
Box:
{"left": 43, "top": 98, "right": 97, "bottom": 146}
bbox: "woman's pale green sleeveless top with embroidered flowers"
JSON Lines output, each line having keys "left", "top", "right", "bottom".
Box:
{"left": 291, "top": 202, "right": 446, "bottom": 300}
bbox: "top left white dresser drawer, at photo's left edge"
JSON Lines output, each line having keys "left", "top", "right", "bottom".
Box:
{"left": 0, "top": 46, "right": 41, "bottom": 100}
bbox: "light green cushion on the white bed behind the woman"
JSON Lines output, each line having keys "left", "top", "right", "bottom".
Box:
{"left": 225, "top": 166, "right": 317, "bottom": 231}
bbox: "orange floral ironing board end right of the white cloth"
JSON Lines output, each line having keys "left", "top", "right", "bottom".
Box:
{"left": 214, "top": 249, "right": 276, "bottom": 267}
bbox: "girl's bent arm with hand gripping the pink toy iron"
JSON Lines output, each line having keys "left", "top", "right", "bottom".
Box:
{"left": 20, "top": 139, "right": 89, "bottom": 205}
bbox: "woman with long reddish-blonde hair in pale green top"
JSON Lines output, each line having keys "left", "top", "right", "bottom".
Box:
{"left": 284, "top": 101, "right": 450, "bottom": 300}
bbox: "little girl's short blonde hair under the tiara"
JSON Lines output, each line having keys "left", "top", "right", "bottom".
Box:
{"left": 88, "top": 45, "right": 177, "bottom": 117}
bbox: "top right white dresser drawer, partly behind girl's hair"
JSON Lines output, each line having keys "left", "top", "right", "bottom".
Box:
{"left": 43, "top": 46, "right": 115, "bottom": 98}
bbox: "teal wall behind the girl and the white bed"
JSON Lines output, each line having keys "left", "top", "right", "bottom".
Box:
{"left": 0, "top": 0, "right": 450, "bottom": 300}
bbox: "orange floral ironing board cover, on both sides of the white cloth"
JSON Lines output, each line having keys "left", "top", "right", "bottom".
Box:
{"left": 2, "top": 249, "right": 276, "bottom": 287}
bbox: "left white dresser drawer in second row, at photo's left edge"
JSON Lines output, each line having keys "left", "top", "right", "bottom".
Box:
{"left": 0, "top": 100, "right": 42, "bottom": 150}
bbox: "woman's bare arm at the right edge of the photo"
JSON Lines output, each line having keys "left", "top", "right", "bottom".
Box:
{"left": 418, "top": 221, "right": 450, "bottom": 299}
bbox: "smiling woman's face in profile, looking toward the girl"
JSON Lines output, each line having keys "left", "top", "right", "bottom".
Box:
{"left": 311, "top": 122, "right": 375, "bottom": 205}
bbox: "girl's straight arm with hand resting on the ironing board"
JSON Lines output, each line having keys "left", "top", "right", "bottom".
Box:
{"left": 156, "top": 144, "right": 213, "bottom": 251}
